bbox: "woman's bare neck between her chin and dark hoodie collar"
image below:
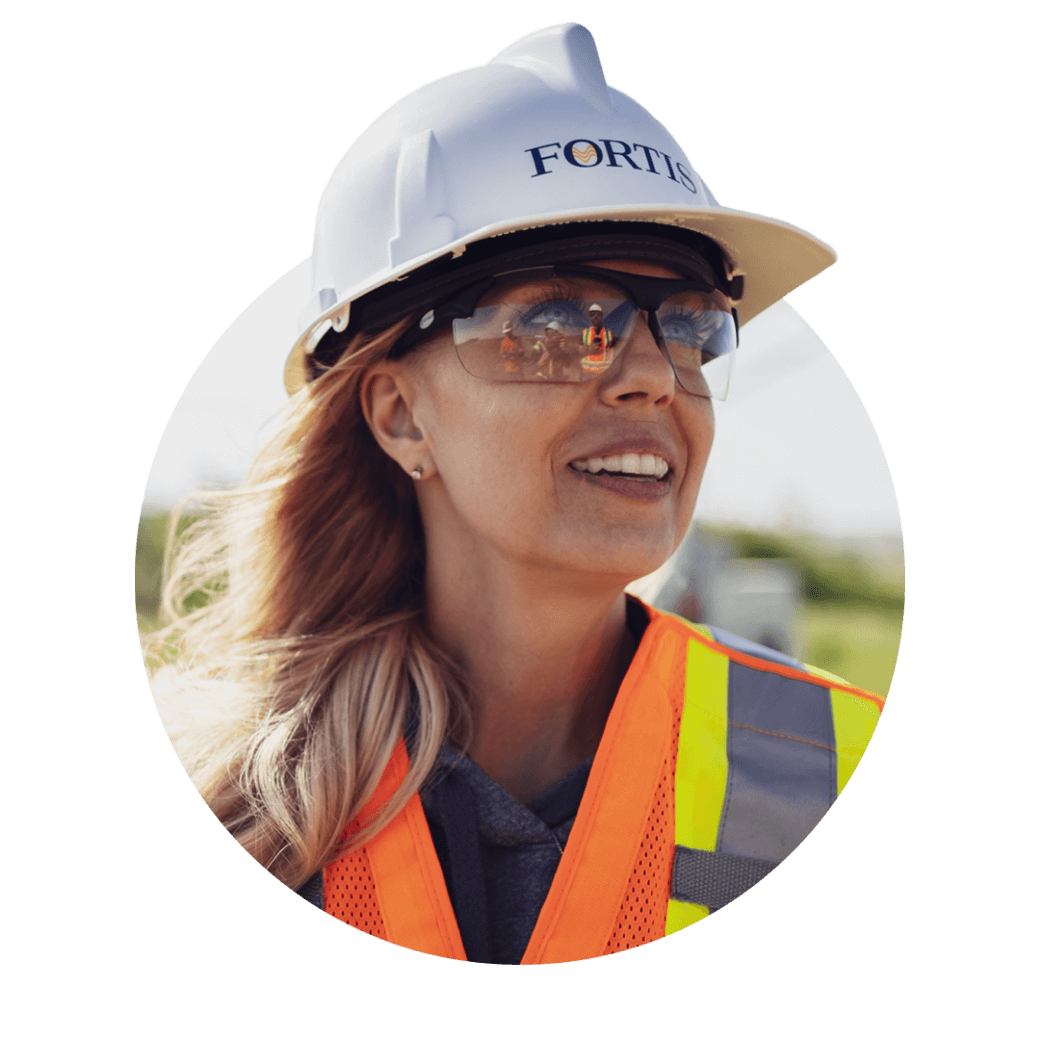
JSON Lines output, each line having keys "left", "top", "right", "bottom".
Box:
{"left": 426, "top": 557, "right": 635, "bottom": 804}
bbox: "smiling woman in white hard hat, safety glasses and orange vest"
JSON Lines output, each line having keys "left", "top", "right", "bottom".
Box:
{"left": 148, "top": 23, "right": 880, "bottom": 963}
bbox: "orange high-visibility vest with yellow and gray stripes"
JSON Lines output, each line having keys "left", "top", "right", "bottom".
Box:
{"left": 323, "top": 604, "right": 883, "bottom": 964}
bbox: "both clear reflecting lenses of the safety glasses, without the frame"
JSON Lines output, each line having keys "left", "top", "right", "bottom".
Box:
{"left": 453, "top": 279, "right": 736, "bottom": 400}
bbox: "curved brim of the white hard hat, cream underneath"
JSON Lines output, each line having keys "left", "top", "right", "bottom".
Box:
{"left": 284, "top": 204, "right": 838, "bottom": 396}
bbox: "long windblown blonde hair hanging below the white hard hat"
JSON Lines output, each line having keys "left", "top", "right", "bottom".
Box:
{"left": 145, "top": 318, "right": 473, "bottom": 889}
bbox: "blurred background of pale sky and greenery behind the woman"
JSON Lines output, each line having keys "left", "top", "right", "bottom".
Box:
{"left": 134, "top": 262, "right": 905, "bottom": 696}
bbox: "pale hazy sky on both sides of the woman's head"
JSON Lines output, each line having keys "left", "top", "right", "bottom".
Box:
{"left": 141, "top": 260, "right": 902, "bottom": 539}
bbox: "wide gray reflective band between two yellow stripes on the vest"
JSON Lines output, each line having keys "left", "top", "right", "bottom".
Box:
{"left": 716, "top": 660, "right": 838, "bottom": 863}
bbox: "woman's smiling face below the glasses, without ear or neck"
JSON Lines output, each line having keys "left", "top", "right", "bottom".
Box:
{"left": 391, "top": 260, "right": 714, "bottom": 583}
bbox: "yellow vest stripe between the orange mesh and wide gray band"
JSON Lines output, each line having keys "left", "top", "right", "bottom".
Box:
{"left": 665, "top": 625, "right": 729, "bottom": 935}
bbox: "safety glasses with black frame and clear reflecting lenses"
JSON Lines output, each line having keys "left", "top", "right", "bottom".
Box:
{"left": 393, "top": 264, "right": 738, "bottom": 400}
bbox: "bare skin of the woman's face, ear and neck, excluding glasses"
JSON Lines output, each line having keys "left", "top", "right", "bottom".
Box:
{"left": 361, "top": 253, "right": 713, "bottom": 804}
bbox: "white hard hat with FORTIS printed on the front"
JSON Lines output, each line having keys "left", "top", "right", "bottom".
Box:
{"left": 285, "top": 22, "right": 837, "bottom": 394}
